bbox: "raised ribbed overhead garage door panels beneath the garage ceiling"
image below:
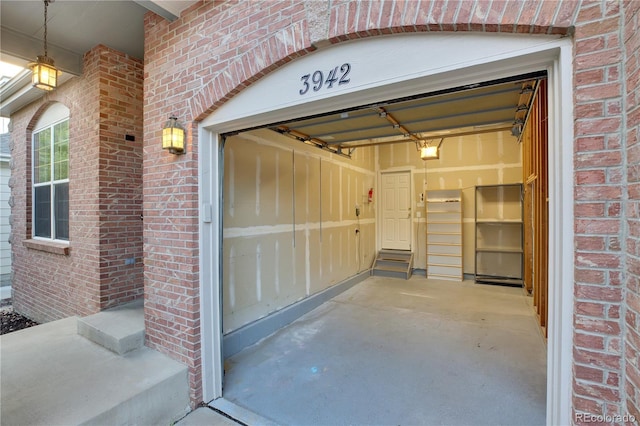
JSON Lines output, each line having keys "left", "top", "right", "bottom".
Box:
{"left": 269, "top": 73, "right": 544, "bottom": 156}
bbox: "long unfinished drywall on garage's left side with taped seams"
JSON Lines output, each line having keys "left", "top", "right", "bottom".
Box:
{"left": 223, "top": 129, "right": 376, "bottom": 333}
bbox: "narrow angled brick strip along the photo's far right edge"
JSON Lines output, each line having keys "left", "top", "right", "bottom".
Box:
{"left": 622, "top": 1, "right": 640, "bottom": 419}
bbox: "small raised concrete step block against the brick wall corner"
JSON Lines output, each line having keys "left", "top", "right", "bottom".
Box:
{"left": 78, "top": 299, "right": 144, "bottom": 355}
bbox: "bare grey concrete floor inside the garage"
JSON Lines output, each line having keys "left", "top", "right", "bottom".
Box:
{"left": 223, "top": 275, "right": 546, "bottom": 425}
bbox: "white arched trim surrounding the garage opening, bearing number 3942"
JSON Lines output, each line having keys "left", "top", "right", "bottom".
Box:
{"left": 199, "top": 33, "right": 573, "bottom": 425}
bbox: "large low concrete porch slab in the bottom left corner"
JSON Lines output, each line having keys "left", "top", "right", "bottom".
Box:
{"left": 0, "top": 317, "right": 189, "bottom": 425}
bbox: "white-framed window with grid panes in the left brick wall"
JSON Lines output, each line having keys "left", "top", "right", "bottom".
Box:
{"left": 32, "top": 118, "right": 69, "bottom": 241}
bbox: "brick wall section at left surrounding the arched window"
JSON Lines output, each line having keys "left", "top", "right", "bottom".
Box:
{"left": 11, "top": 46, "right": 143, "bottom": 322}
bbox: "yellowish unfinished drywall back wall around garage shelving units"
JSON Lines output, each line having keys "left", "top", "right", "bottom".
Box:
{"left": 377, "top": 131, "right": 522, "bottom": 274}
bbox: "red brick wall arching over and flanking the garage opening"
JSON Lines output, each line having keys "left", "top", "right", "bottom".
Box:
{"left": 144, "top": 0, "right": 638, "bottom": 415}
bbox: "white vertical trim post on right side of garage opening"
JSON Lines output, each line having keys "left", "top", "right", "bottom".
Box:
{"left": 547, "top": 40, "right": 574, "bottom": 425}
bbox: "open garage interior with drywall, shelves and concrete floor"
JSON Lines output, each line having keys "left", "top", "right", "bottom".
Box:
{"left": 215, "top": 71, "right": 547, "bottom": 424}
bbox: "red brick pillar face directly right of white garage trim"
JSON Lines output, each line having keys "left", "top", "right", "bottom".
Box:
{"left": 573, "top": 2, "right": 625, "bottom": 422}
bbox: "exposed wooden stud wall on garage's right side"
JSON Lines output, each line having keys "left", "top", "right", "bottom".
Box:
{"left": 522, "top": 80, "right": 549, "bottom": 337}
